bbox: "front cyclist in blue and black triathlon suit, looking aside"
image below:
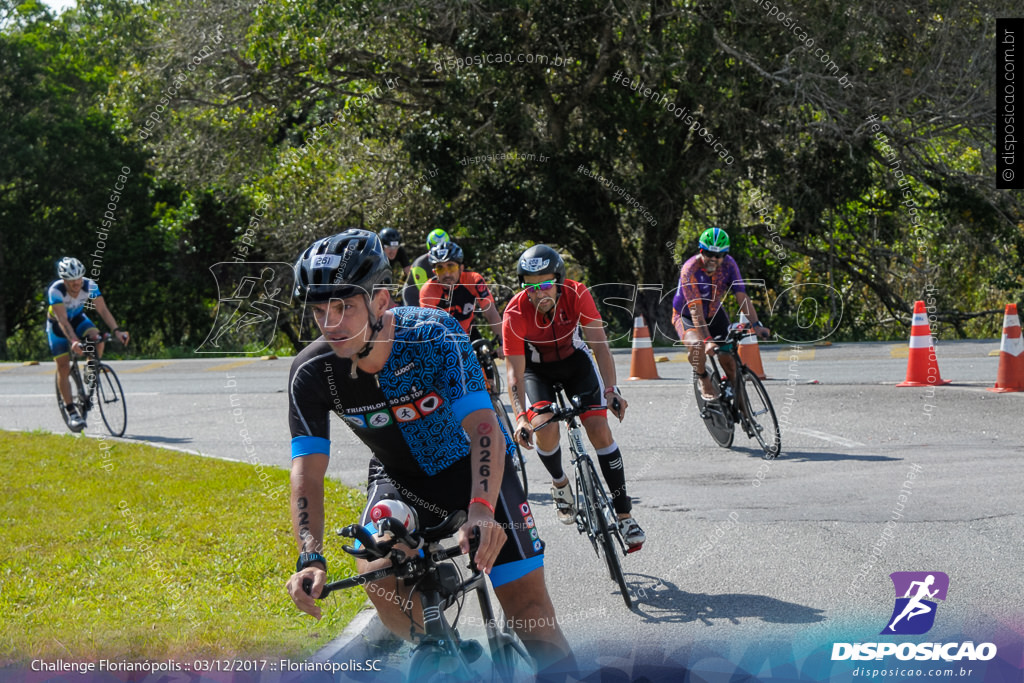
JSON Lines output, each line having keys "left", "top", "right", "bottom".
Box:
{"left": 288, "top": 229, "right": 573, "bottom": 670}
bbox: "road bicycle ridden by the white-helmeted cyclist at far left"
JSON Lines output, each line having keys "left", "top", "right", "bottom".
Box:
{"left": 54, "top": 333, "right": 128, "bottom": 436}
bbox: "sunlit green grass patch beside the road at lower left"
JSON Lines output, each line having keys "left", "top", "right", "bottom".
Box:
{"left": 0, "top": 432, "right": 365, "bottom": 666}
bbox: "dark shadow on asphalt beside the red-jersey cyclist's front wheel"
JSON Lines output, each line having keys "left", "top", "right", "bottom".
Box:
{"left": 626, "top": 573, "right": 825, "bottom": 626}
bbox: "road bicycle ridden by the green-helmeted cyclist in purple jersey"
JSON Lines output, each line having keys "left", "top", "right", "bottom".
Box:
{"left": 693, "top": 327, "right": 782, "bottom": 460}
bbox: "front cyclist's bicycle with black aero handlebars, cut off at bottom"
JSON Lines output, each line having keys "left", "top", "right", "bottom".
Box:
{"left": 302, "top": 510, "right": 534, "bottom": 683}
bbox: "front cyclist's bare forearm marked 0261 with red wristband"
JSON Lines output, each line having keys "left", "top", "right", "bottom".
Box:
{"left": 459, "top": 409, "right": 506, "bottom": 573}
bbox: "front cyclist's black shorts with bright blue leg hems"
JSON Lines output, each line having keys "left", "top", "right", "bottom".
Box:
{"left": 359, "top": 458, "right": 544, "bottom": 588}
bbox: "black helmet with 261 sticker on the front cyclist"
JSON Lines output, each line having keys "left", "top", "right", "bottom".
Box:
{"left": 295, "top": 228, "right": 391, "bottom": 303}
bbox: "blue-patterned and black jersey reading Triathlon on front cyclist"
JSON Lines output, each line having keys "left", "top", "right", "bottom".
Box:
{"left": 289, "top": 306, "right": 514, "bottom": 479}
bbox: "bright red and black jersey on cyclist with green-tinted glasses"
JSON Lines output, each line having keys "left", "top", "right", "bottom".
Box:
{"left": 502, "top": 280, "right": 601, "bottom": 362}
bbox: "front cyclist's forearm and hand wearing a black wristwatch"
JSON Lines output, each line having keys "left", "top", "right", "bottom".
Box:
{"left": 288, "top": 453, "right": 330, "bottom": 618}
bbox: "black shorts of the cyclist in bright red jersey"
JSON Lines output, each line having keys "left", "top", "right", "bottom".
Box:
{"left": 523, "top": 348, "right": 608, "bottom": 421}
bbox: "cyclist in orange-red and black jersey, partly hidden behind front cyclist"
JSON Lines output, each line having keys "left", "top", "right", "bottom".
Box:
{"left": 420, "top": 242, "right": 502, "bottom": 350}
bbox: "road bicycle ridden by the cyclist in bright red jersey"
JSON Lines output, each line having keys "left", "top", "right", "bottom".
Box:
{"left": 534, "top": 384, "right": 640, "bottom": 608}
